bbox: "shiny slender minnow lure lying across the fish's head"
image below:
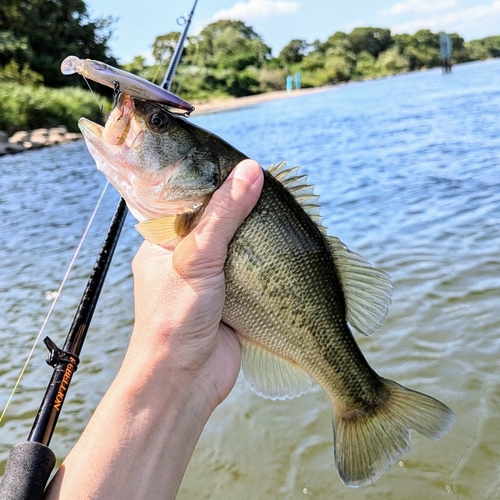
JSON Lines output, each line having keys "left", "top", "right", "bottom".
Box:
{"left": 61, "top": 56, "right": 194, "bottom": 115}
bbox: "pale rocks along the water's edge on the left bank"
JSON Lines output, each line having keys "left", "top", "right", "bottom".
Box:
{"left": 0, "top": 126, "right": 82, "bottom": 156}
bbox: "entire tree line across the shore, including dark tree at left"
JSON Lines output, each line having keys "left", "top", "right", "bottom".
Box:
{"left": 0, "top": 0, "right": 500, "bottom": 99}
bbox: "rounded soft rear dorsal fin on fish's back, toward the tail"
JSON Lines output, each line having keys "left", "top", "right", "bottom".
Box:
{"left": 326, "top": 236, "right": 392, "bottom": 335}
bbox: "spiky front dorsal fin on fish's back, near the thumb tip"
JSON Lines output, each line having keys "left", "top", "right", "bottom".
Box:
{"left": 267, "top": 161, "right": 326, "bottom": 235}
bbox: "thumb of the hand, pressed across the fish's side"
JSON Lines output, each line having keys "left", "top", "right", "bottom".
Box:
{"left": 174, "top": 160, "right": 264, "bottom": 272}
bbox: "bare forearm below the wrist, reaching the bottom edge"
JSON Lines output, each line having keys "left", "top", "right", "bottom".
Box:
{"left": 45, "top": 340, "right": 214, "bottom": 500}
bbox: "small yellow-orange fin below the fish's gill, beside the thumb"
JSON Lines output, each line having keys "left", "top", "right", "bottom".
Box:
{"left": 135, "top": 209, "right": 201, "bottom": 245}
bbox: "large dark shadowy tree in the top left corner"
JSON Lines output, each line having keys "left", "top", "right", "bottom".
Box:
{"left": 0, "top": 0, "right": 116, "bottom": 87}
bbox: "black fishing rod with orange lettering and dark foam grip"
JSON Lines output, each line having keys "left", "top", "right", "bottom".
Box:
{"left": 0, "top": 0, "right": 198, "bottom": 500}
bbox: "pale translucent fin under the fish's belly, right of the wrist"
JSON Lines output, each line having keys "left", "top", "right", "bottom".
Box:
{"left": 239, "top": 337, "right": 312, "bottom": 400}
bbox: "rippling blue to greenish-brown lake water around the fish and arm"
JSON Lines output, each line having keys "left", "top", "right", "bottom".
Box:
{"left": 0, "top": 60, "right": 500, "bottom": 500}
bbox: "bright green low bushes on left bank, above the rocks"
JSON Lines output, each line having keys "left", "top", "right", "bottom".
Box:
{"left": 0, "top": 82, "right": 111, "bottom": 135}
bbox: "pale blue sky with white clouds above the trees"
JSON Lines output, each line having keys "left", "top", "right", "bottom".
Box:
{"left": 85, "top": 0, "right": 500, "bottom": 63}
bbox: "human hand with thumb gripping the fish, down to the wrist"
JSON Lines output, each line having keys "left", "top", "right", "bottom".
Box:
{"left": 124, "top": 160, "right": 263, "bottom": 411}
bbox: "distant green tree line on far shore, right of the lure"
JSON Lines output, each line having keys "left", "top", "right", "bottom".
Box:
{"left": 133, "top": 20, "right": 500, "bottom": 99}
